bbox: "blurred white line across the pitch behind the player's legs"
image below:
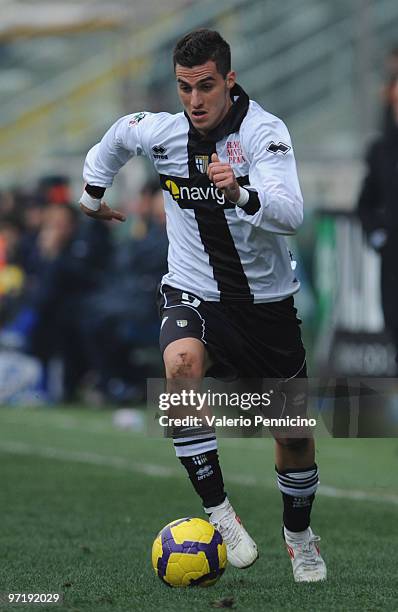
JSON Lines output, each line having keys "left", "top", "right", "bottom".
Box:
{"left": 0, "top": 442, "right": 398, "bottom": 504}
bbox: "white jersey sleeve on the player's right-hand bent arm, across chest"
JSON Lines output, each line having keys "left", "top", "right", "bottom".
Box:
{"left": 237, "top": 112, "right": 303, "bottom": 235}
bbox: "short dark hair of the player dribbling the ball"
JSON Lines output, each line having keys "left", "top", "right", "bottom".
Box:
{"left": 173, "top": 28, "right": 231, "bottom": 78}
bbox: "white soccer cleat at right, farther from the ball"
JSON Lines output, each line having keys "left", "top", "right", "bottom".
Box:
{"left": 283, "top": 527, "right": 326, "bottom": 582}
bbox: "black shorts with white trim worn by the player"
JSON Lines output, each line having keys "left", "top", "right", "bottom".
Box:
{"left": 159, "top": 285, "right": 306, "bottom": 380}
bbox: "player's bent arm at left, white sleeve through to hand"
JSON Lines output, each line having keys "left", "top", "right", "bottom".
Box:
{"left": 80, "top": 113, "right": 152, "bottom": 221}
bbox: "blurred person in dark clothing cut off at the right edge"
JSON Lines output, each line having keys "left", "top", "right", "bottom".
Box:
{"left": 358, "top": 72, "right": 398, "bottom": 368}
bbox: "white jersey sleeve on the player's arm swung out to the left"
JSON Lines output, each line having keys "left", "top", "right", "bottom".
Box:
{"left": 83, "top": 112, "right": 156, "bottom": 188}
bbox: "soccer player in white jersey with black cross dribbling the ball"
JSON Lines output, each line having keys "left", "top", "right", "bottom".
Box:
{"left": 80, "top": 29, "right": 326, "bottom": 582}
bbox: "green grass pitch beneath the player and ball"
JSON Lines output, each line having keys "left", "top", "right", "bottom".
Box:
{"left": 0, "top": 408, "right": 398, "bottom": 612}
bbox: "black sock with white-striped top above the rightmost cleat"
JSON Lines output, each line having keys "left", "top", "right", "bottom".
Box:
{"left": 276, "top": 463, "right": 319, "bottom": 532}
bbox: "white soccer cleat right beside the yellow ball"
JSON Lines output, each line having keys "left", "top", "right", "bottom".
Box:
{"left": 205, "top": 498, "right": 258, "bottom": 569}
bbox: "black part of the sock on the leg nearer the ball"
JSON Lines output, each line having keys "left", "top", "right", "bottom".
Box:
{"left": 179, "top": 450, "right": 226, "bottom": 508}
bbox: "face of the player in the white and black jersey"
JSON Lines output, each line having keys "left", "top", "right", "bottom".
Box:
{"left": 175, "top": 60, "right": 235, "bottom": 134}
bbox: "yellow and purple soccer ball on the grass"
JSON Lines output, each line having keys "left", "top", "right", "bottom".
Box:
{"left": 152, "top": 518, "right": 227, "bottom": 587}
